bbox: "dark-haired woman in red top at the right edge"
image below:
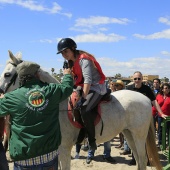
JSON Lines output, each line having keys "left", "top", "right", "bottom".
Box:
{"left": 152, "top": 83, "right": 170, "bottom": 146}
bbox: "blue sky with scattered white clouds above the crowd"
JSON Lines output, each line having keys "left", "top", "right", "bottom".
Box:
{"left": 0, "top": 0, "right": 170, "bottom": 78}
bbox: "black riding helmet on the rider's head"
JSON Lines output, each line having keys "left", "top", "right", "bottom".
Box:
{"left": 57, "top": 38, "right": 77, "bottom": 54}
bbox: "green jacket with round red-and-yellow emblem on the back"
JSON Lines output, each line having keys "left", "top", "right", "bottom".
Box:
{"left": 0, "top": 74, "right": 73, "bottom": 161}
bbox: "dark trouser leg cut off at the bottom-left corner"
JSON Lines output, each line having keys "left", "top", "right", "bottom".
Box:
{"left": 0, "top": 142, "right": 9, "bottom": 170}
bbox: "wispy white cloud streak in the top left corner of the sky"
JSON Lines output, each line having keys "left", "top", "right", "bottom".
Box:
{"left": 0, "top": 0, "right": 72, "bottom": 17}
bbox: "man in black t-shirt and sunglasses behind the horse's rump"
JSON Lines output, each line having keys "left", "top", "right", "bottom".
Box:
{"left": 126, "top": 71, "right": 167, "bottom": 165}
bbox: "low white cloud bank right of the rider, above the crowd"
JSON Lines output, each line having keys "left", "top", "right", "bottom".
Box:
{"left": 97, "top": 57, "right": 170, "bottom": 78}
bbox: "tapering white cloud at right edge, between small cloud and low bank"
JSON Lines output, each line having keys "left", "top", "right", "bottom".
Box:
{"left": 133, "top": 29, "right": 170, "bottom": 40}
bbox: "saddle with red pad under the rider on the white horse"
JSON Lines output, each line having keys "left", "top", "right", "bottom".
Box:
{"left": 68, "top": 87, "right": 111, "bottom": 143}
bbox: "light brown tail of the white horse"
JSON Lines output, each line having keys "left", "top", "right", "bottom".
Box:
{"left": 146, "top": 118, "right": 162, "bottom": 170}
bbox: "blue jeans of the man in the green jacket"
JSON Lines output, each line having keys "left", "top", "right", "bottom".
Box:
{"left": 14, "top": 156, "right": 58, "bottom": 170}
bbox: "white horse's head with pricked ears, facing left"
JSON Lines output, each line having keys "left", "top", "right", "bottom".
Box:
{"left": 0, "top": 50, "right": 22, "bottom": 92}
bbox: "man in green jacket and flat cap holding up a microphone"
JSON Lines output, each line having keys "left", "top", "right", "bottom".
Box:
{"left": 0, "top": 61, "right": 73, "bottom": 170}
